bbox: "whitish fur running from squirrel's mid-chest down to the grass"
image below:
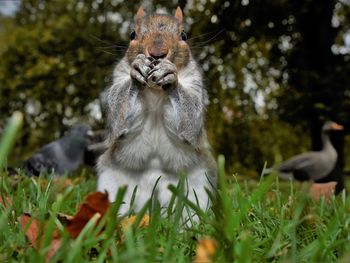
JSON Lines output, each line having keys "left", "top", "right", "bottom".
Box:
{"left": 97, "top": 88, "right": 211, "bottom": 214}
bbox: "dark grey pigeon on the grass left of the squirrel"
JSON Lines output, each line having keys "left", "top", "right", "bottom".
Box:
{"left": 24, "top": 124, "right": 92, "bottom": 176}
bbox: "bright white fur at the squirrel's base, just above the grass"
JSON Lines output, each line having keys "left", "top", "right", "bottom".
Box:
{"left": 97, "top": 168, "right": 210, "bottom": 214}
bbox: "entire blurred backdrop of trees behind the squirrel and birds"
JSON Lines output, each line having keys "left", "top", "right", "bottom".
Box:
{"left": 0, "top": 0, "right": 350, "bottom": 182}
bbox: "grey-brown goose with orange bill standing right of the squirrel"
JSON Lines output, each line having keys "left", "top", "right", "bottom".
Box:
{"left": 279, "top": 122, "right": 344, "bottom": 181}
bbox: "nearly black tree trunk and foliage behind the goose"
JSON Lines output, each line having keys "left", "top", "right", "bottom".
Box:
{"left": 277, "top": 0, "right": 350, "bottom": 192}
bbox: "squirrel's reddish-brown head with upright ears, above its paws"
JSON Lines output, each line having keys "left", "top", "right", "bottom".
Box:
{"left": 127, "top": 7, "right": 190, "bottom": 68}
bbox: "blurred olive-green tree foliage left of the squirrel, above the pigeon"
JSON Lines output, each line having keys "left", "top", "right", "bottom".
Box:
{"left": 0, "top": 0, "right": 144, "bottom": 158}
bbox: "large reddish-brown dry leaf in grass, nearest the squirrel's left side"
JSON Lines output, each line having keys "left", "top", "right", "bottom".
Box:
{"left": 66, "top": 192, "right": 110, "bottom": 238}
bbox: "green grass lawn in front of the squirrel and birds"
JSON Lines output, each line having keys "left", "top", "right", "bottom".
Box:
{"left": 0, "top": 157, "right": 350, "bottom": 262}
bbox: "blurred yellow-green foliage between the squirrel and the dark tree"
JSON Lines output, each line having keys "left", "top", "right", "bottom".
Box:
{"left": 185, "top": 0, "right": 306, "bottom": 174}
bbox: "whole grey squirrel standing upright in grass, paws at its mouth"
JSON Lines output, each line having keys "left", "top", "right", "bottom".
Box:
{"left": 97, "top": 7, "right": 217, "bottom": 217}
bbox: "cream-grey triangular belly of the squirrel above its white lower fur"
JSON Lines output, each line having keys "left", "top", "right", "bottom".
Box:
{"left": 114, "top": 114, "right": 199, "bottom": 173}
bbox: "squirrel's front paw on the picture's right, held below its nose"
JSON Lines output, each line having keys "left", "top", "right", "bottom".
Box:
{"left": 147, "top": 59, "right": 177, "bottom": 89}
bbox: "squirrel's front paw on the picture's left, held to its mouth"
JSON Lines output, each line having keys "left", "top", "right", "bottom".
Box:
{"left": 130, "top": 54, "right": 154, "bottom": 85}
